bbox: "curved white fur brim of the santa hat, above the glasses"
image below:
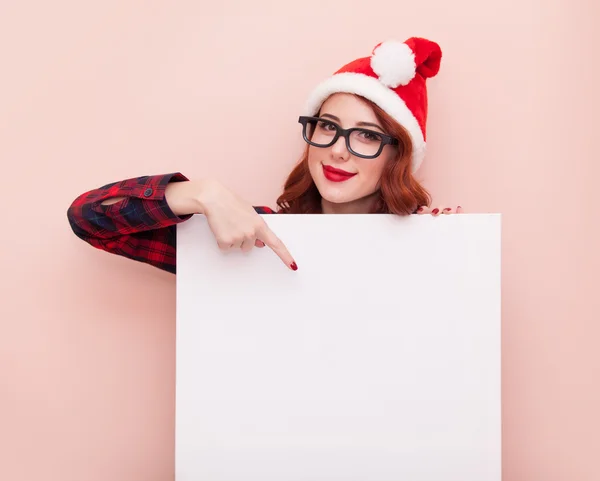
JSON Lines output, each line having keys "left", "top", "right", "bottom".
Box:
{"left": 305, "top": 72, "right": 426, "bottom": 172}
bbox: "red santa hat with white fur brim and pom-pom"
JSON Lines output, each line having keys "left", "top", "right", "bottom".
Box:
{"left": 306, "top": 37, "right": 442, "bottom": 172}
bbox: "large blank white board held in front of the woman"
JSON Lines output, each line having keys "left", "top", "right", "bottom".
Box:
{"left": 175, "top": 214, "right": 501, "bottom": 481}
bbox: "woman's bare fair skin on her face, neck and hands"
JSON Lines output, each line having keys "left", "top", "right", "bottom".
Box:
{"left": 103, "top": 94, "right": 460, "bottom": 270}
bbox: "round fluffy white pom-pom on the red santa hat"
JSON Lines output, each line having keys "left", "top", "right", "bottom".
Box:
{"left": 371, "top": 40, "right": 417, "bottom": 88}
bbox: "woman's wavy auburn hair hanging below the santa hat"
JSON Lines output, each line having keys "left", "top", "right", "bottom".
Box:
{"left": 277, "top": 96, "right": 431, "bottom": 215}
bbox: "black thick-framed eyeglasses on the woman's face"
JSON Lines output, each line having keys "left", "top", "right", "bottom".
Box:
{"left": 298, "top": 116, "right": 399, "bottom": 159}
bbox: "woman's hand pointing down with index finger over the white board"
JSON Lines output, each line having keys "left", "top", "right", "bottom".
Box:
{"left": 198, "top": 180, "right": 298, "bottom": 270}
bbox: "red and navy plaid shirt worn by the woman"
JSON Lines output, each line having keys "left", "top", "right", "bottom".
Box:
{"left": 67, "top": 172, "right": 274, "bottom": 274}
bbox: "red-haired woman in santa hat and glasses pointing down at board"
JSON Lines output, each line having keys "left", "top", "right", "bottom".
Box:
{"left": 68, "top": 38, "right": 460, "bottom": 273}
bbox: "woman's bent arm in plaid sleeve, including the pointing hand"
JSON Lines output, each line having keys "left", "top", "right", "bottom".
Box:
{"left": 67, "top": 173, "right": 282, "bottom": 273}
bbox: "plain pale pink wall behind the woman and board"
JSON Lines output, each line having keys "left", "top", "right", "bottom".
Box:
{"left": 0, "top": 0, "right": 600, "bottom": 481}
